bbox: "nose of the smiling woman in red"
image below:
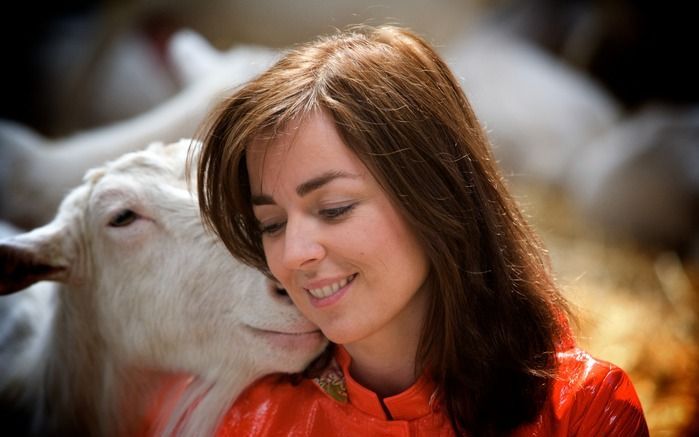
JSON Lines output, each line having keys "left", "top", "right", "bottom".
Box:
{"left": 283, "top": 218, "right": 325, "bottom": 270}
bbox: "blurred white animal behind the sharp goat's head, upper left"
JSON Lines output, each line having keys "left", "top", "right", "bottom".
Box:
{"left": 0, "top": 30, "right": 276, "bottom": 228}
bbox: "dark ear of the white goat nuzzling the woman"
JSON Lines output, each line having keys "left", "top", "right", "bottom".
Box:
{"left": 0, "top": 240, "right": 66, "bottom": 296}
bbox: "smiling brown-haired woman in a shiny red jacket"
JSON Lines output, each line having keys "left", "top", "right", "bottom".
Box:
{"left": 198, "top": 27, "right": 648, "bottom": 436}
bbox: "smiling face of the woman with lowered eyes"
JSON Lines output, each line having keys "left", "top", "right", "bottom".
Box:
{"left": 247, "top": 112, "right": 429, "bottom": 344}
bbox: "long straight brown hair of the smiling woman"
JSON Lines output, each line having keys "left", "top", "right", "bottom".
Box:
{"left": 198, "top": 26, "right": 567, "bottom": 435}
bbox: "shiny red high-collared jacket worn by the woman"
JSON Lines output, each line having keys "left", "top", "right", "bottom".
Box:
{"left": 217, "top": 347, "right": 648, "bottom": 437}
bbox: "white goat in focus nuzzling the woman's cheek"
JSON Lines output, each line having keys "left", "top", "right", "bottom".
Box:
{"left": 0, "top": 140, "right": 325, "bottom": 435}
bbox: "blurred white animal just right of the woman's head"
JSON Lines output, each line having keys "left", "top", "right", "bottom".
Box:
{"left": 444, "top": 23, "right": 621, "bottom": 185}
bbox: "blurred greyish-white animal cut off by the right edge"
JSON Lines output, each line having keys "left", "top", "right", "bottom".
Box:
{"left": 563, "top": 105, "right": 699, "bottom": 252}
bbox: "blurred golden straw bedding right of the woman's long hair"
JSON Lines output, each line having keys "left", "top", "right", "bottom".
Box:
{"left": 513, "top": 182, "right": 699, "bottom": 436}
